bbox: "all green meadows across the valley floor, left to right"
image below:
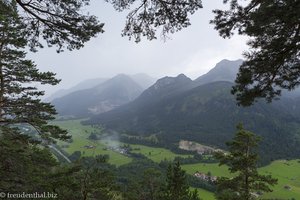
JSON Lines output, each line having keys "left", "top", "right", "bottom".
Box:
{"left": 53, "top": 119, "right": 300, "bottom": 200}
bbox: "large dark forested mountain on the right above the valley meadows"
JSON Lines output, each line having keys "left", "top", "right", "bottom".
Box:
{"left": 86, "top": 60, "right": 300, "bottom": 161}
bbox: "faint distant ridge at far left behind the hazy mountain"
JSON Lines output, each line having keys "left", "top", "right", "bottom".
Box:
{"left": 44, "top": 78, "right": 108, "bottom": 102}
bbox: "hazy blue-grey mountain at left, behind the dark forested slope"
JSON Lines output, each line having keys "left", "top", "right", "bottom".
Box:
{"left": 52, "top": 74, "right": 143, "bottom": 117}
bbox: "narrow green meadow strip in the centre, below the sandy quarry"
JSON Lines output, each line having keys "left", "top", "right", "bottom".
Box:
{"left": 130, "top": 145, "right": 191, "bottom": 162}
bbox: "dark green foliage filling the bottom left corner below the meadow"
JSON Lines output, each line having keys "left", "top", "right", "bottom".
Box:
{"left": 0, "top": 126, "right": 119, "bottom": 200}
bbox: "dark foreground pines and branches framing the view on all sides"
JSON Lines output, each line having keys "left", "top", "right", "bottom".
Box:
{"left": 0, "top": 0, "right": 300, "bottom": 200}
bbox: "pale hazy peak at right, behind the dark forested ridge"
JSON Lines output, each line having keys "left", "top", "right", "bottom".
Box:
{"left": 194, "top": 59, "right": 243, "bottom": 86}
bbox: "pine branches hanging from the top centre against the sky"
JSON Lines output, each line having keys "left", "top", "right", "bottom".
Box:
{"left": 106, "top": 0, "right": 202, "bottom": 42}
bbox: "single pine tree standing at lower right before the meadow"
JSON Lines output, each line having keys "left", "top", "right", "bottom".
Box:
{"left": 216, "top": 124, "right": 277, "bottom": 200}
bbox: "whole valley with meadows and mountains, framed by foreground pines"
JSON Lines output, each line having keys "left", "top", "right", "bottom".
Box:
{"left": 51, "top": 60, "right": 300, "bottom": 200}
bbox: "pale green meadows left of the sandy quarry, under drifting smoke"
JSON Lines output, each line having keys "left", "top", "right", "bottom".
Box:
{"left": 54, "top": 120, "right": 190, "bottom": 166}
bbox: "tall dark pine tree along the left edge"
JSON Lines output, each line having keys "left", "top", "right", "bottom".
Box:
{"left": 0, "top": 3, "right": 73, "bottom": 192}
